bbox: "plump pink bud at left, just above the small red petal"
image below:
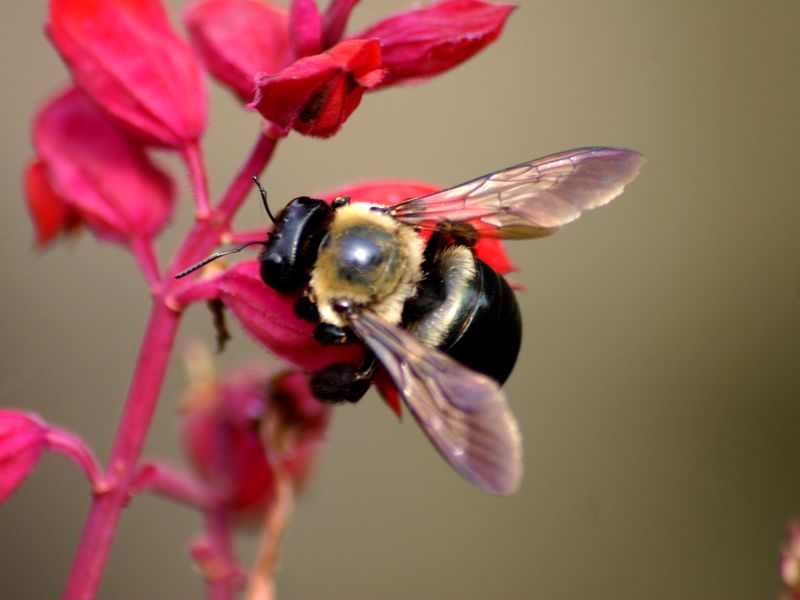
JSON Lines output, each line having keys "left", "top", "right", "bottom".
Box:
{"left": 28, "top": 89, "right": 174, "bottom": 243}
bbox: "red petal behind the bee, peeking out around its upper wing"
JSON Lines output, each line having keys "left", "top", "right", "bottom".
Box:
{"left": 316, "top": 179, "right": 516, "bottom": 275}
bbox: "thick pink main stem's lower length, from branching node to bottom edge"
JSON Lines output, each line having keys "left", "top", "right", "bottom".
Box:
{"left": 64, "top": 300, "right": 179, "bottom": 600}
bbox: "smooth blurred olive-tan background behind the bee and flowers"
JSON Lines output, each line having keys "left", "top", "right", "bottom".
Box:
{"left": 0, "top": 0, "right": 800, "bottom": 600}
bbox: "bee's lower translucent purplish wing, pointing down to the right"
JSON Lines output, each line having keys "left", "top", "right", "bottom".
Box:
{"left": 349, "top": 312, "right": 522, "bottom": 495}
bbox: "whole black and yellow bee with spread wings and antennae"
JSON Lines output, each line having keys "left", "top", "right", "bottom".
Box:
{"left": 177, "top": 147, "right": 644, "bottom": 495}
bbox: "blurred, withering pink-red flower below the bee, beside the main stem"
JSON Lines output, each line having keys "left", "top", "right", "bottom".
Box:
{"left": 183, "top": 358, "right": 330, "bottom": 516}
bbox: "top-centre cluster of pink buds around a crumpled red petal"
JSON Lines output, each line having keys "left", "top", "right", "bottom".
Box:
{"left": 186, "top": 0, "right": 513, "bottom": 137}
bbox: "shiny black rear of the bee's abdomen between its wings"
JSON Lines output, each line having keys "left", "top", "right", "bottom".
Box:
{"left": 441, "top": 258, "right": 522, "bottom": 384}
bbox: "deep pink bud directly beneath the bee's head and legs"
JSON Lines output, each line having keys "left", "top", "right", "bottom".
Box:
{"left": 218, "top": 260, "right": 363, "bottom": 371}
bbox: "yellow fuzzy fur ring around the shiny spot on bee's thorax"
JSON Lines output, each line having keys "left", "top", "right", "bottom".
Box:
{"left": 310, "top": 203, "right": 425, "bottom": 326}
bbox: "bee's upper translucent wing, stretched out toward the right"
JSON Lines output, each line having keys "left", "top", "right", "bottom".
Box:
{"left": 388, "top": 148, "right": 644, "bottom": 239}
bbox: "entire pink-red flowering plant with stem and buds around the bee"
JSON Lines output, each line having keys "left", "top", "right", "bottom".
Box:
{"left": 9, "top": 0, "right": 513, "bottom": 598}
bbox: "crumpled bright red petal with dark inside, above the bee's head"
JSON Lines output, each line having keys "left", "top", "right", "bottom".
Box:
{"left": 249, "top": 40, "right": 383, "bottom": 137}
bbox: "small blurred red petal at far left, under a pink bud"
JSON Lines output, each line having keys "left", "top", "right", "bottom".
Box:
{"left": 25, "top": 159, "right": 80, "bottom": 246}
